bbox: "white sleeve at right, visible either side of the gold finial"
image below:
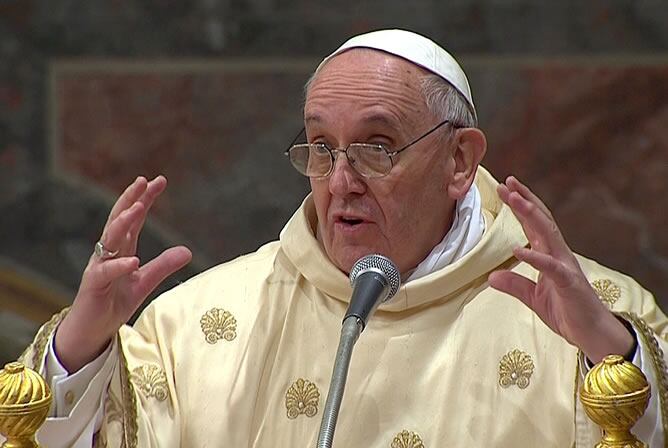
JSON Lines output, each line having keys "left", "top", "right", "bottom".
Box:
{"left": 580, "top": 335, "right": 665, "bottom": 448}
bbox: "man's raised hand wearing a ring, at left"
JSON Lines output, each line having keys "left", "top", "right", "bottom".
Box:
{"left": 55, "top": 176, "right": 192, "bottom": 372}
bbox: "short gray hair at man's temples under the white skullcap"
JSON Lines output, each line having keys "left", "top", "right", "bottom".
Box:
{"left": 304, "top": 72, "right": 478, "bottom": 128}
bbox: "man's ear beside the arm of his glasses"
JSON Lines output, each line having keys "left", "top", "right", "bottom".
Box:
{"left": 448, "top": 128, "right": 487, "bottom": 199}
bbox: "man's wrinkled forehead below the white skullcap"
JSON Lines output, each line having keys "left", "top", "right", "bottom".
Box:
{"left": 304, "top": 48, "right": 426, "bottom": 128}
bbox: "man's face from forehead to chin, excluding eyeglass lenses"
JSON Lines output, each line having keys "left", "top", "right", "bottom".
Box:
{"left": 304, "top": 49, "right": 456, "bottom": 274}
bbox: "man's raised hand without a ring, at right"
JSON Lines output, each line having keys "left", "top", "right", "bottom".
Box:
{"left": 489, "top": 176, "right": 634, "bottom": 362}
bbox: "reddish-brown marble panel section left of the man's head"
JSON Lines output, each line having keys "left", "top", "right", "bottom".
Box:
{"left": 54, "top": 67, "right": 308, "bottom": 264}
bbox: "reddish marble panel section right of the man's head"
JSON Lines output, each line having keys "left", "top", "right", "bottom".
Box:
{"left": 483, "top": 65, "right": 668, "bottom": 309}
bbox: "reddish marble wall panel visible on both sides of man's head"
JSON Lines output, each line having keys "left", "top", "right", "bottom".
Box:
{"left": 54, "top": 62, "right": 668, "bottom": 308}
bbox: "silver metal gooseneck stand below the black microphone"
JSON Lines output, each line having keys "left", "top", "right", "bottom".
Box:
{"left": 317, "top": 315, "right": 364, "bottom": 448}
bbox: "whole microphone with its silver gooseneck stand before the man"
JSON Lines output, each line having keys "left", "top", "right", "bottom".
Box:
{"left": 317, "top": 255, "right": 401, "bottom": 448}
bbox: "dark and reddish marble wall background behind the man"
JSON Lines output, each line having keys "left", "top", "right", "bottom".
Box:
{"left": 0, "top": 0, "right": 668, "bottom": 363}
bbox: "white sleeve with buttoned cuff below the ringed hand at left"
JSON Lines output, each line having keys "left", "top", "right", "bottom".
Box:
{"left": 37, "top": 339, "right": 118, "bottom": 448}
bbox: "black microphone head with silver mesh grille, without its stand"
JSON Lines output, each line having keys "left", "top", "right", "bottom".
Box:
{"left": 343, "top": 254, "right": 401, "bottom": 330}
